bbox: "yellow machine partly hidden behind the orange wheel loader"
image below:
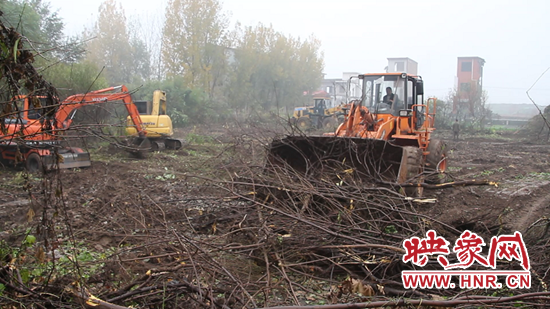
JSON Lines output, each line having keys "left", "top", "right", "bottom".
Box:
{"left": 291, "top": 92, "right": 346, "bottom": 130}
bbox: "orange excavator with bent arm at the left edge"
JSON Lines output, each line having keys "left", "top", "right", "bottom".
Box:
{"left": 0, "top": 85, "right": 150, "bottom": 172}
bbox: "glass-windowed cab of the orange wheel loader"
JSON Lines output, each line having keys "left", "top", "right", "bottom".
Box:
{"left": 359, "top": 73, "right": 423, "bottom": 116}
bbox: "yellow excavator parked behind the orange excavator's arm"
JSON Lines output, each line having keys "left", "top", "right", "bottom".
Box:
{"left": 126, "top": 90, "right": 182, "bottom": 151}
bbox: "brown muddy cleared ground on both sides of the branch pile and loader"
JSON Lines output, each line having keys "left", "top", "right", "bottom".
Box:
{"left": 0, "top": 128, "right": 550, "bottom": 308}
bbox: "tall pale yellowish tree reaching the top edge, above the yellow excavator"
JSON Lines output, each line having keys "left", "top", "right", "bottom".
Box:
{"left": 161, "top": 0, "right": 228, "bottom": 98}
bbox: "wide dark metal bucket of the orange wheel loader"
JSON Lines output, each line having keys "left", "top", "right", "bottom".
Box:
{"left": 267, "top": 136, "right": 410, "bottom": 182}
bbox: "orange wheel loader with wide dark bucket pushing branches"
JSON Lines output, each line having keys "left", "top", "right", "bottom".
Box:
{"left": 268, "top": 73, "right": 447, "bottom": 195}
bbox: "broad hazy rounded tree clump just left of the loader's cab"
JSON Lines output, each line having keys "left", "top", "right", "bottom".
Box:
{"left": 225, "top": 24, "right": 323, "bottom": 113}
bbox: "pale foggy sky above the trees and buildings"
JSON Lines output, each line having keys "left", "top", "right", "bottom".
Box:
{"left": 46, "top": 0, "right": 550, "bottom": 105}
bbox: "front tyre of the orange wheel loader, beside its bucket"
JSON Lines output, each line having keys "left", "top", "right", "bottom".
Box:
{"left": 397, "top": 146, "right": 424, "bottom": 197}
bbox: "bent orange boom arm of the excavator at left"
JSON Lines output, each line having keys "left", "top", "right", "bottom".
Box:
{"left": 54, "top": 85, "right": 147, "bottom": 137}
